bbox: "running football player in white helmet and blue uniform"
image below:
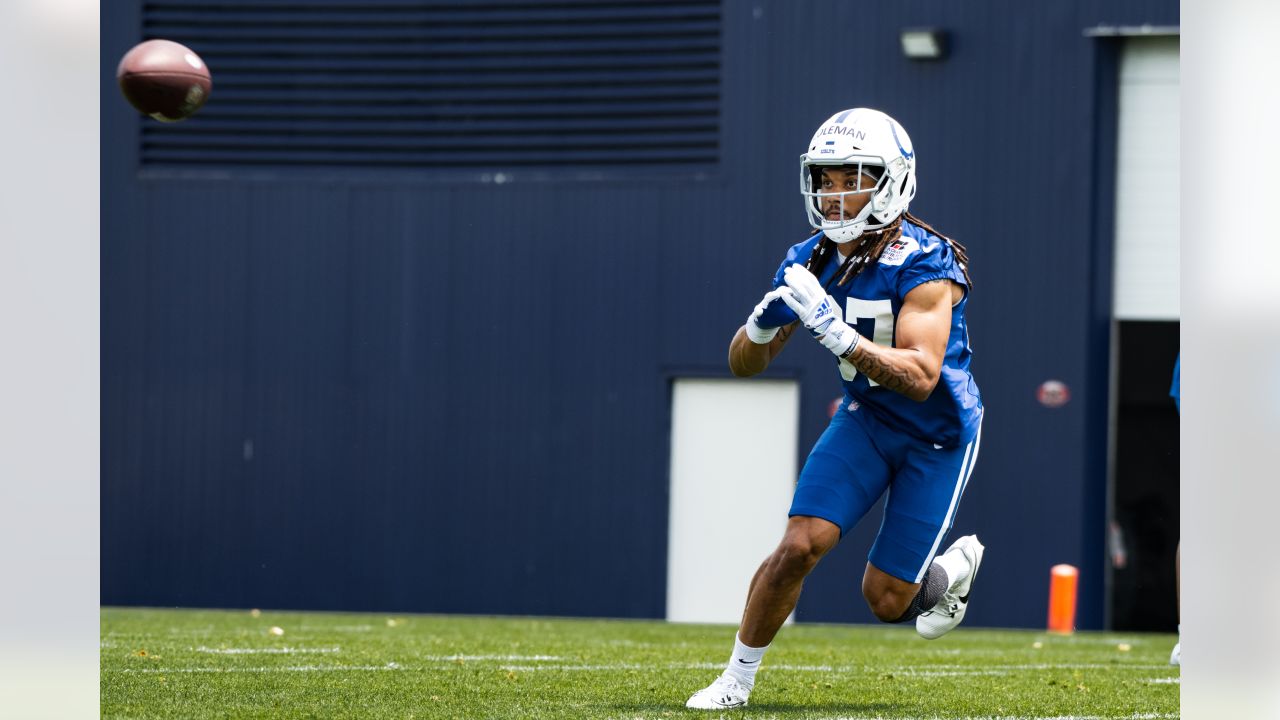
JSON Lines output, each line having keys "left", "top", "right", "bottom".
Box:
{"left": 687, "top": 108, "right": 983, "bottom": 710}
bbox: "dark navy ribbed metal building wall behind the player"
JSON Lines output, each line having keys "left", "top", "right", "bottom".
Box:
{"left": 101, "top": 0, "right": 1178, "bottom": 628}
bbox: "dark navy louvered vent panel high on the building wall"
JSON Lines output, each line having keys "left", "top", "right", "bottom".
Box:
{"left": 142, "top": 0, "right": 721, "bottom": 169}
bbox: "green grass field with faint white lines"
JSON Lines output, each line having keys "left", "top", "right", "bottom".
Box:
{"left": 101, "top": 609, "right": 1179, "bottom": 720}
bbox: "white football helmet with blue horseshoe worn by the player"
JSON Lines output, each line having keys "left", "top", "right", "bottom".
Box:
{"left": 800, "top": 108, "right": 915, "bottom": 242}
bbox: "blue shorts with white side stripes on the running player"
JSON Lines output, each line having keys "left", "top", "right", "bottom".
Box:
{"left": 788, "top": 404, "right": 982, "bottom": 583}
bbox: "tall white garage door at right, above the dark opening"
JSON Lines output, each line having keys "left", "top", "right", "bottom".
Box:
{"left": 1115, "top": 36, "right": 1177, "bottom": 320}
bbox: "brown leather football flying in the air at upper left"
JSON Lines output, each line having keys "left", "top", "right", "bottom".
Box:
{"left": 115, "top": 40, "right": 214, "bottom": 123}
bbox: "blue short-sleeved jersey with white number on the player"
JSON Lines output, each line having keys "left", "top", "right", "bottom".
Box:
{"left": 760, "top": 219, "right": 982, "bottom": 447}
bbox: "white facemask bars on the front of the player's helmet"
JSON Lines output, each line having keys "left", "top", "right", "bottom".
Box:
{"left": 800, "top": 155, "right": 892, "bottom": 245}
